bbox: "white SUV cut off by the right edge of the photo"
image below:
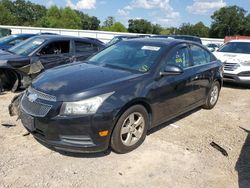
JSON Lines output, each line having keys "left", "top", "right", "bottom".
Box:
{"left": 214, "top": 40, "right": 250, "bottom": 84}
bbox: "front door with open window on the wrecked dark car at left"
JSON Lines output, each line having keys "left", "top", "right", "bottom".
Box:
{"left": 38, "top": 40, "right": 72, "bottom": 69}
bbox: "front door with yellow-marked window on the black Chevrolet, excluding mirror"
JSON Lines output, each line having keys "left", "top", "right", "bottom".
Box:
{"left": 152, "top": 44, "right": 195, "bottom": 124}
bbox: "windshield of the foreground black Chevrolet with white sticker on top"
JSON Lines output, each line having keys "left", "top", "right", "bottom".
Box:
{"left": 88, "top": 42, "right": 162, "bottom": 73}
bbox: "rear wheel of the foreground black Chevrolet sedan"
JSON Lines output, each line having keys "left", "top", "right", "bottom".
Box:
{"left": 202, "top": 81, "right": 221, "bottom": 109}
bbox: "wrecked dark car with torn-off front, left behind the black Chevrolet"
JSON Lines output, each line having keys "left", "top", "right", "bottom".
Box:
{"left": 0, "top": 35, "right": 104, "bottom": 91}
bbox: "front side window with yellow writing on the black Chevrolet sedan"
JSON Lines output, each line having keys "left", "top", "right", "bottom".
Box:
{"left": 166, "top": 47, "right": 191, "bottom": 68}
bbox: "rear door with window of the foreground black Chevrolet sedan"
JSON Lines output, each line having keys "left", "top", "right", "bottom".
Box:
{"left": 190, "top": 44, "right": 217, "bottom": 101}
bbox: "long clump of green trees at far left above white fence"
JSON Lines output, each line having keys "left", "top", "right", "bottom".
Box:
{"left": 0, "top": 0, "right": 100, "bottom": 30}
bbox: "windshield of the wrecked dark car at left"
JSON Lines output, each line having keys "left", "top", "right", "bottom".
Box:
{"left": 9, "top": 37, "right": 45, "bottom": 55}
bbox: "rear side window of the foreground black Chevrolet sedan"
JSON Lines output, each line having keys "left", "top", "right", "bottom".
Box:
{"left": 191, "top": 45, "right": 211, "bottom": 66}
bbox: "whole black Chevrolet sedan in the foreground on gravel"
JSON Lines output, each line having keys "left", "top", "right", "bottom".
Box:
{"left": 20, "top": 39, "right": 223, "bottom": 153}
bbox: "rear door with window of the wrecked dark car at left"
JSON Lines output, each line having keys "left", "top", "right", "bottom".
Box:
{"left": 74, "top": 40, "right": 99, "bottom": 61}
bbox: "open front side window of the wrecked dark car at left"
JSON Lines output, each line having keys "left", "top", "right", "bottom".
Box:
{"left": 40, "top": 41, "right": 70, "bottom": 55}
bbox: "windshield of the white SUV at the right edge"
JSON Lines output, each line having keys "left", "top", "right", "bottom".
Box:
{"left": 218, "top": 42, "right": 250, "bottom": 54}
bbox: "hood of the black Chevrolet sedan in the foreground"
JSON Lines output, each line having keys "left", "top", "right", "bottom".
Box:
{"left": 32, "top": 63, "right": 141, "bottom": 101}
